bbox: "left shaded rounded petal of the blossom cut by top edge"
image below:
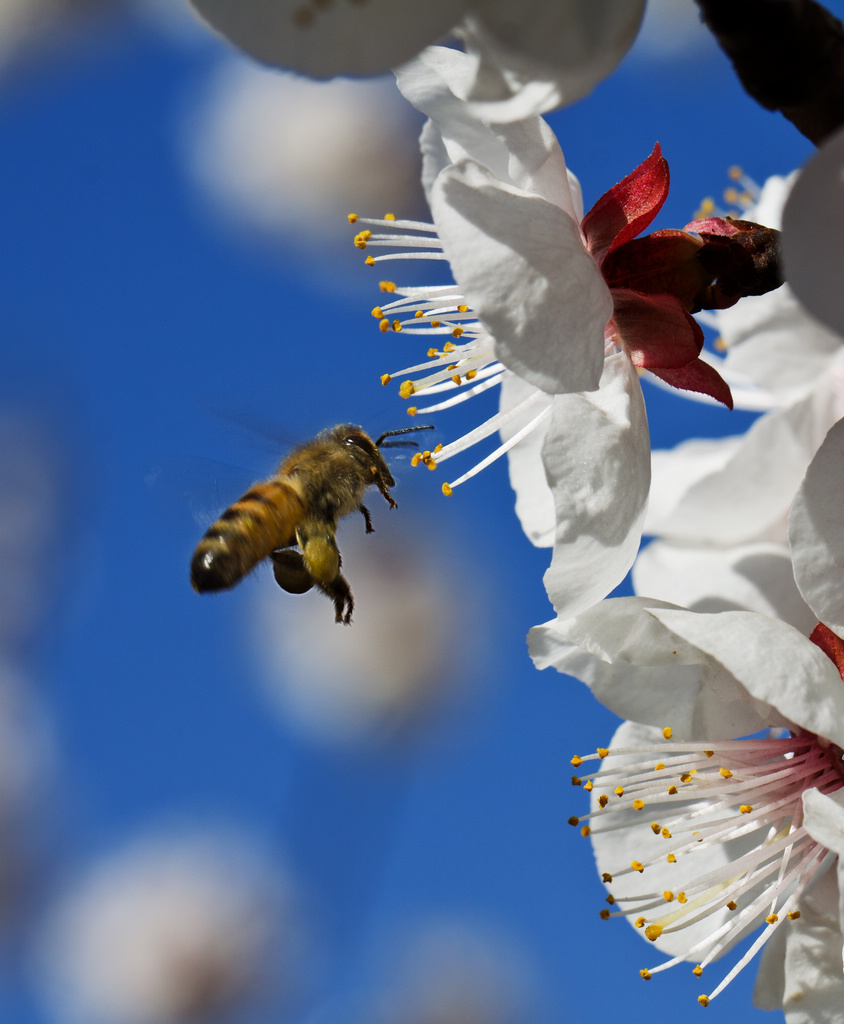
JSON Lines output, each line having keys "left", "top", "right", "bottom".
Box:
{"left": 191, "top": 0, "right": 460, "bottom": 78}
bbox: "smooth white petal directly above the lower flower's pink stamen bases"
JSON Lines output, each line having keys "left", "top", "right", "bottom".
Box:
{"left": 652, "top": 609, "right": 844, "bottom": 744}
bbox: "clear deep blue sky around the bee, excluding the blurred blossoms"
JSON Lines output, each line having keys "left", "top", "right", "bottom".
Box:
{"left": 0, "top": 4, "right": 844, "bottom": 1024}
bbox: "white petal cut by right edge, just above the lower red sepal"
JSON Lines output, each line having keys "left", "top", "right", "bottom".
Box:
{"left": 789, "top": 420, "right": 844, "bottom": 636}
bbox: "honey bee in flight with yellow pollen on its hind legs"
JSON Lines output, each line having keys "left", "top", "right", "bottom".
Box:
{"left": 191, "top": 423, "right": 433, "bottom": 624}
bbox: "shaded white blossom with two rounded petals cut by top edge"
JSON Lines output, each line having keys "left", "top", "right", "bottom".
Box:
{"left": 192, "top": 0, "right": 644, "bottom": 122}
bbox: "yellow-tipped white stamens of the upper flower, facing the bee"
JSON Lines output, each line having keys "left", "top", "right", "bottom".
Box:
{"left": 348, "top": 214, "right": 549, "bottom": 496}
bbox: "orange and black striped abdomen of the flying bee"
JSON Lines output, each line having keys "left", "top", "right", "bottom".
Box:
{"left": 191, "top": 477, "right": 305, "bottom": 594}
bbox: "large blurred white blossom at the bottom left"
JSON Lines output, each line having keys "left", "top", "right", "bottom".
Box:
{"left": 41, "top": 830, "right": 298, "bottom": 1024}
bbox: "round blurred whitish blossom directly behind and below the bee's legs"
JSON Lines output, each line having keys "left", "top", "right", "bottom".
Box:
{"left": 246, "top": 522, "right": 471, "bottom": 743}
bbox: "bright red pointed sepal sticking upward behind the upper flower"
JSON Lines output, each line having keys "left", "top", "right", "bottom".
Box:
{"left": 581, "top": 142, "right": 669, "bottom": 265}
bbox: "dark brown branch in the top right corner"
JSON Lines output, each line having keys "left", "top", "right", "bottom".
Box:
{"left": 697, "top": 0, "right": 844, "bottom": 145}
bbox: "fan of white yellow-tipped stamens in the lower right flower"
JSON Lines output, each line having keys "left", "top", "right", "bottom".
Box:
{"left": 568, "top": 729, "right": 844, "bottom": 1007}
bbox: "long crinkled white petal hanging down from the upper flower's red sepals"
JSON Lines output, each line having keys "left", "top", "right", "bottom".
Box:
{"left": 543, "top": 352, "right": 650, "bottom": 616}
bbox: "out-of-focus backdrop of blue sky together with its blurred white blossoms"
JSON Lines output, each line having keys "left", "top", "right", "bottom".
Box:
{"left": 0, "top": 0, "right": 831, "bottom": 1024}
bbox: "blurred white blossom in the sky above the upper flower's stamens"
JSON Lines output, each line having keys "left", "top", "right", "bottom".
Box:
{"left": 185, "top": 58, "right": 422, "bottom": 251}
